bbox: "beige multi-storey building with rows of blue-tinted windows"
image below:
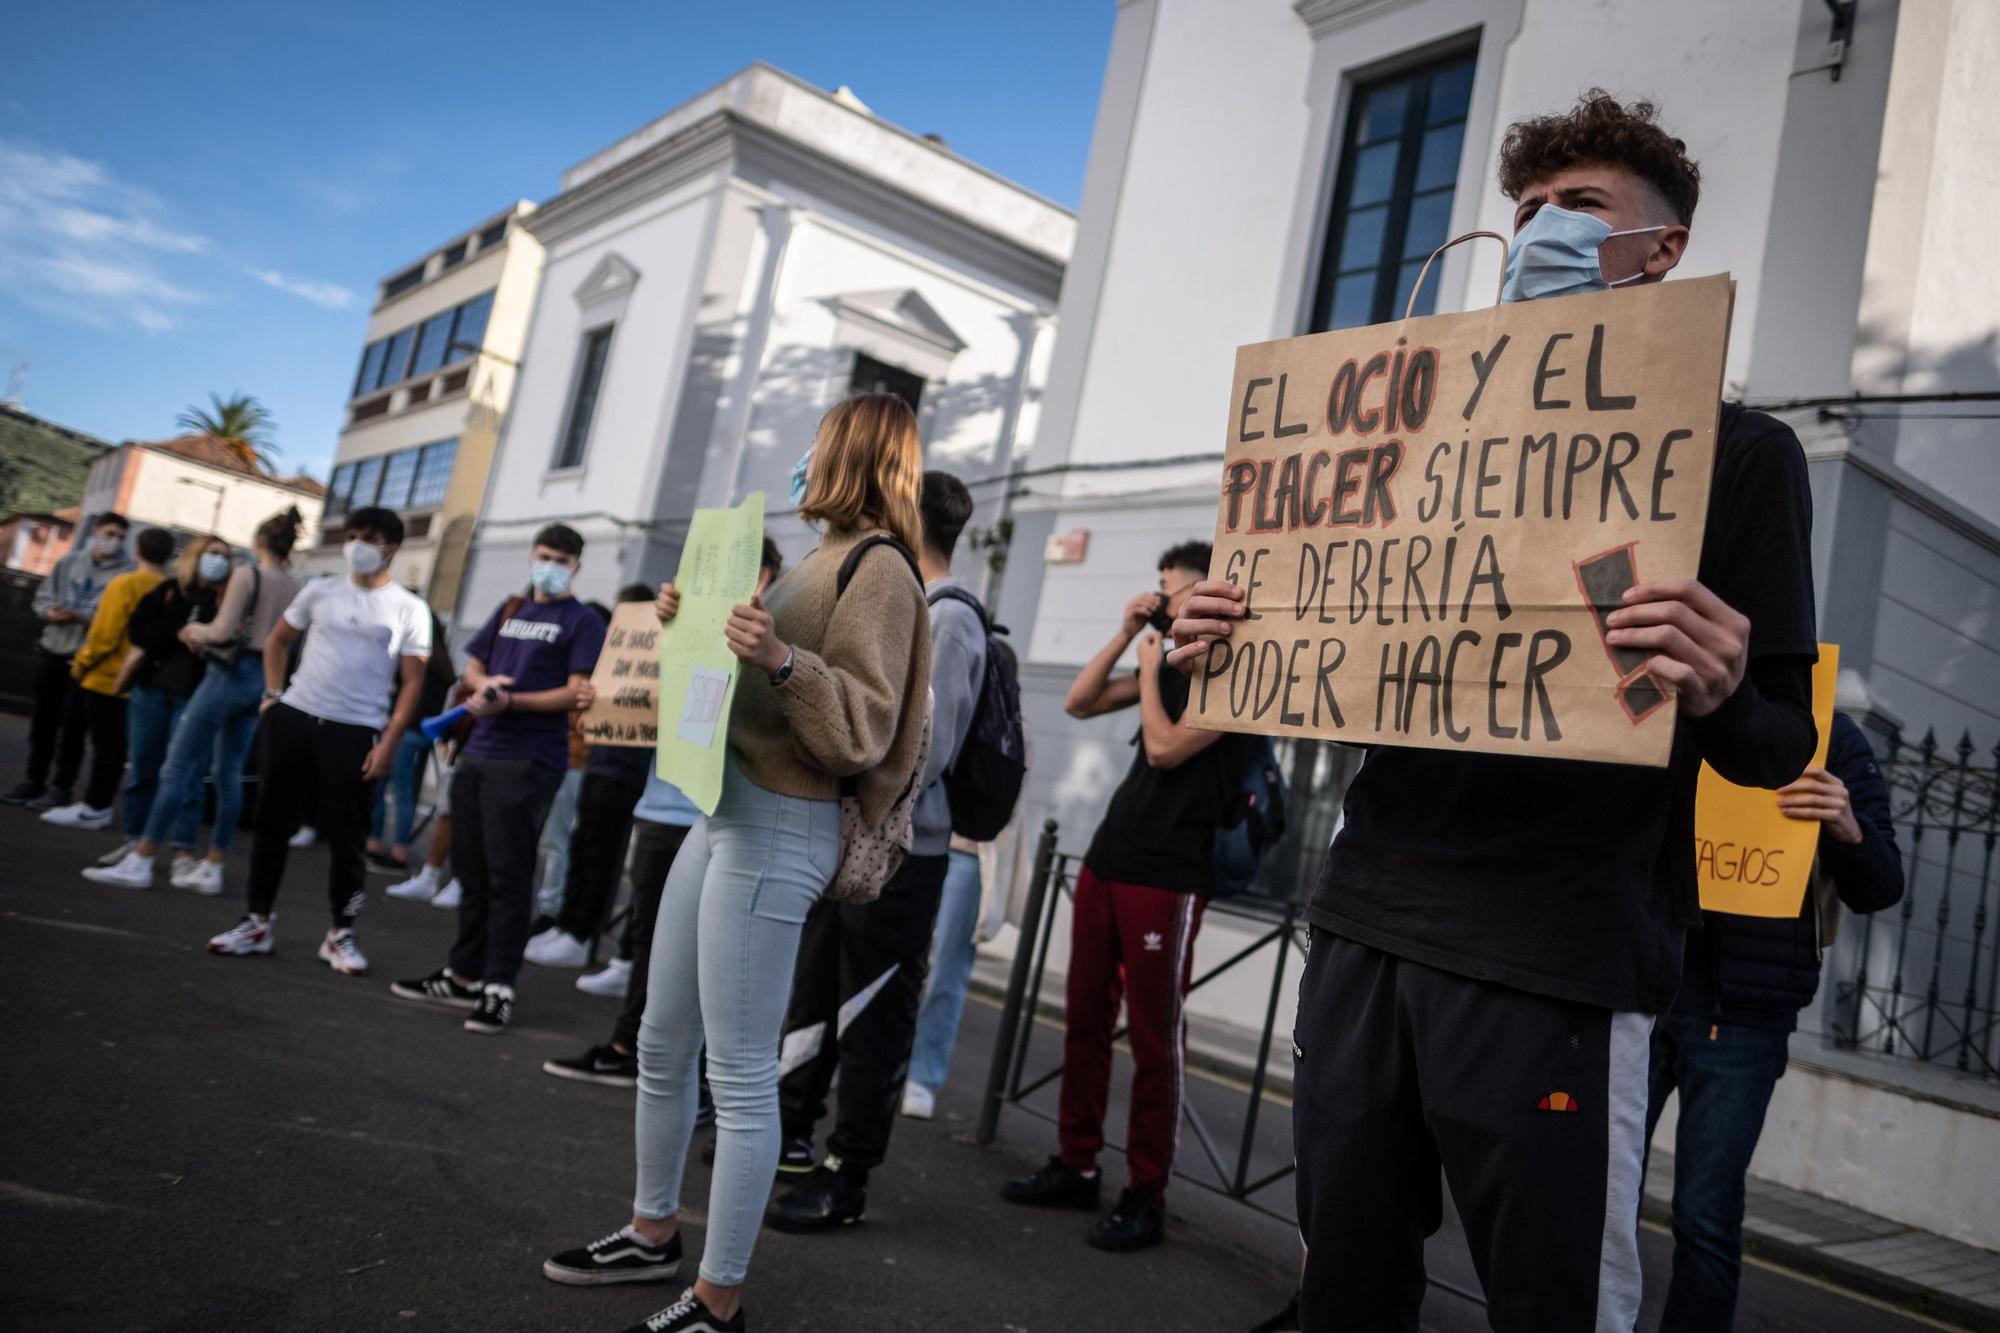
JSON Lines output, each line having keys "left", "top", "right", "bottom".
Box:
{"left": 306, "top": 202, "right": 542, "bottom": 612}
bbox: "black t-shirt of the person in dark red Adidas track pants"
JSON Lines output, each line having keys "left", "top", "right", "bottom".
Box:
{"left": 1084, "top": 662, "right": 1262, "bottom": 897}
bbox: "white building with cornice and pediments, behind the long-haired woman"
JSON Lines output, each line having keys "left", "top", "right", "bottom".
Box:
{"left": 458, "top": 66, "right": 1074, "bottom": 626}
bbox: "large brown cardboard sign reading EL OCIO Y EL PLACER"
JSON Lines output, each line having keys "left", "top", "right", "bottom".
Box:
{"left": 1188, "top": 276, "right": 1734, "bottom": 767}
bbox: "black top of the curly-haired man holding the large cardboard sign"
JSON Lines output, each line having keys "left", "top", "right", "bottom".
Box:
{"left": 1310, "top": 402, "right": 1818, "bottom": 1013}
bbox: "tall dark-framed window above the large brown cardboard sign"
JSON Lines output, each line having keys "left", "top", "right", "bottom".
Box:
{"left": 1312, "top": 54, "right": 1474, "bottom": 332}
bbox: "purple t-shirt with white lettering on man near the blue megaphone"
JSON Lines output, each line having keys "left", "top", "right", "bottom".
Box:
{"left": 466, "top": 596, "right": 604, "bottom": 769}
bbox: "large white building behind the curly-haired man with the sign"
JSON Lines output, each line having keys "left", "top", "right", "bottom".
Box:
{"left": 998, "top": 0, "right": 2000, "bottom": 1247}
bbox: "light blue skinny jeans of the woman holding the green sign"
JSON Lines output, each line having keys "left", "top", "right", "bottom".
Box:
{"left": 632, "top": 761, "right": 840, "bottom": 1287}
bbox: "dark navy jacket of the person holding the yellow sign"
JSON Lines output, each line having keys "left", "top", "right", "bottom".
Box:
{"left": 1674, "top": 713, "right": 1902, "bottom": 1033}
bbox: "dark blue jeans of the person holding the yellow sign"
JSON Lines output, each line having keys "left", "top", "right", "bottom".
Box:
{"left": 1646, "top": 1015, "right": 1790, "bottom": 1333}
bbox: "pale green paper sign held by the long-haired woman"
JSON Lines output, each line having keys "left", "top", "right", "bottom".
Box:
{"left": 658, "top": 490, "right": 764, "bottom": 815}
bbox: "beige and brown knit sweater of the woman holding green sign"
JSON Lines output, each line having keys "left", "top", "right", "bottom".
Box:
{"left": 730, "top": 532, "right": 930, "bottom": 823}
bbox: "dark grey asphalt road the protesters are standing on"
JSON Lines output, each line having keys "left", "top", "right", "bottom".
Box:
{"left": 0, "top": 719, "right": 1936, "bottom": 1333}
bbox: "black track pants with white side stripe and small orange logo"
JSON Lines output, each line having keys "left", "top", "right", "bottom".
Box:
{"left": 1292, "top": 929, "right": 1652, "bottom": 1333}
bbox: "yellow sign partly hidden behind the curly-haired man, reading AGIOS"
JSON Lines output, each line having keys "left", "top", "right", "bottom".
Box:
{"left": 1694, "top": 642, "right": 1840, "bottom": 917}
